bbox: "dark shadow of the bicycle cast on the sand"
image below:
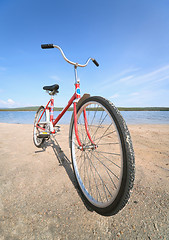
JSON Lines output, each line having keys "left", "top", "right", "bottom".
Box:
{"left": 39, "top": 136, "right": 93, "bottom": 212}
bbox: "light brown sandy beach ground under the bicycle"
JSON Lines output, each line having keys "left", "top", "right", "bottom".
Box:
{"left": 0, "top": 123, "right": 169, "bottom": 240}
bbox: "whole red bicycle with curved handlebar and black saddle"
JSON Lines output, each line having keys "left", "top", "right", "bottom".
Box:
{"left": 33, "top": 44, "right": 135, "bottom": 215}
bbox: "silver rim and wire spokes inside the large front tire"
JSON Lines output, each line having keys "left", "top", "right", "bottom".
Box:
{"left": 72, "top": 101, "right": 123, "bottom": 208}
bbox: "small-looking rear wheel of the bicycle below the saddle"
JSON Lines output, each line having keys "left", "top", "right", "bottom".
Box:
{"left": 33, "top": 106, "right": 46, "bottom": 147}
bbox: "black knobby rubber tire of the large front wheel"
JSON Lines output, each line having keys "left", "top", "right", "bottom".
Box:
{"left": 70, "top": 96, "right": 135, "bottom": 216}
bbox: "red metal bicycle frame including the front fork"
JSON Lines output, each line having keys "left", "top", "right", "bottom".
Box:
{"left": 36, "top": 66, "right": 96, "bottom": 150}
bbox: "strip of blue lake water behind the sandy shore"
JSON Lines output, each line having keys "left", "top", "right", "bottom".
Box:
{"left": 0, "top": 111, "right": 169, "bottom": 124}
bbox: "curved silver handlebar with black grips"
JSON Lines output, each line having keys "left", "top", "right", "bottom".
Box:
{"left": 41, "top": 44, "right": 99, "bottom": 67}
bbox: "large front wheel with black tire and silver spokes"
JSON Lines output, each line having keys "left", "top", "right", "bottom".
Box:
{"left": 70, "top": 97, "right": 135, "bottom": 215}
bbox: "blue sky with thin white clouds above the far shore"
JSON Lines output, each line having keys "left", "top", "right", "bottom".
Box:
{"left": 0, "top": 0, "right": 169, "bottom": 108}
